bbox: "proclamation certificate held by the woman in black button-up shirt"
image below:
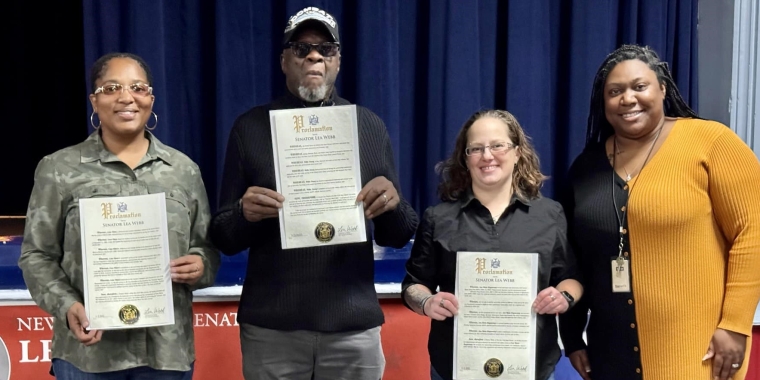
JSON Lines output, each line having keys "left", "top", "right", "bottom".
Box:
{"left": 453, "top": 252, "right": 538, "bottom": 380}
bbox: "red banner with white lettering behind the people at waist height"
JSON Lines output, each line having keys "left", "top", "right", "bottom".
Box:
{"left": 0, "top": 300, "right": 430, "bottom": 380}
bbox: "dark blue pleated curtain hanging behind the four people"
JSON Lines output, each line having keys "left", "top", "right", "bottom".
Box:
{"left": 82, "top": 0, "right": 697, "bottom": 212}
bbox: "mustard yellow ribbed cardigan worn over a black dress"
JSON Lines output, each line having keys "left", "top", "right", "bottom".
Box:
{"left": 628, "top": 119, "right": 760, "bottom": 380}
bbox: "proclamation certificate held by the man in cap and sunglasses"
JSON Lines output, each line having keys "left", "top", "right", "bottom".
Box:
{"left": 269, "top": 105, "right": 367, "bottom": 249}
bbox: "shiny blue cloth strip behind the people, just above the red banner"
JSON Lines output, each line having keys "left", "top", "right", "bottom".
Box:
{"left": 0, "top": 236, "right": 412, "bottom": 289}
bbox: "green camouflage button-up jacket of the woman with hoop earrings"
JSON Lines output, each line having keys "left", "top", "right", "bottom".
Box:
{"left": 19, "top": 132, "right": 220, "bottom": 372}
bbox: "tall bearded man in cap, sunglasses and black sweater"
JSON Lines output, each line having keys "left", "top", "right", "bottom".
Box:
{"left": 211, "top": 7, "right": 417, "bottom": 380}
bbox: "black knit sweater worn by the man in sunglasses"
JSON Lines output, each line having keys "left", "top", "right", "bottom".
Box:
{"left": 210, "top": 93, "right": 417, "bottom": 332}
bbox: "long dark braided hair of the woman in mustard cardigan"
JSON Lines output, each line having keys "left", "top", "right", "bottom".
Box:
{"left": 586, "top": 45, "right": 699, "bottom": 146}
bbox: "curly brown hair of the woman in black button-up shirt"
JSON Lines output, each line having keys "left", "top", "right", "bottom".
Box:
{"left": 436, "top": 110, "right": 548, "bottom": 201}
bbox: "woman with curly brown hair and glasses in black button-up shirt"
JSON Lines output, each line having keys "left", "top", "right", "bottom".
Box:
{"left": 402, "top": 110, "right": 583, "bottom": 380}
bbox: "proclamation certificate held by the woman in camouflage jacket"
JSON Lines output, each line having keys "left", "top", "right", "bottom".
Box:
{"left": 79, "top": 193, "right": 174, "bottom": 330}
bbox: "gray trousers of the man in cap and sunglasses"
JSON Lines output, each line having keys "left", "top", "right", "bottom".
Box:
{"left": 240, "top": 323, "right": 385, "bottom": 380}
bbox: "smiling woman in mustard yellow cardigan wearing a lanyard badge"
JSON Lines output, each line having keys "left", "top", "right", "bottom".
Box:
{"left": 560, "top": 45, "right": 760, "bottom": 380}
